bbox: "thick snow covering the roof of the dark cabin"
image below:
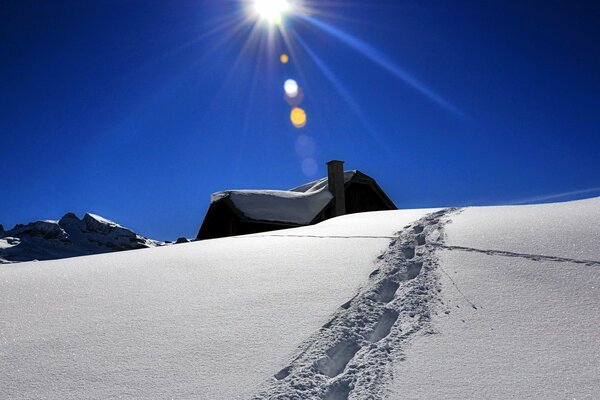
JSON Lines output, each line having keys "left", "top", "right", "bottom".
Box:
{"left": 211, "top": 171, "right": 357, "bottom": 225}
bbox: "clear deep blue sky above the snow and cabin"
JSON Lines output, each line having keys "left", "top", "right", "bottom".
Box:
{"left": 0, "top": 0, "right": 600, "bottom": 239}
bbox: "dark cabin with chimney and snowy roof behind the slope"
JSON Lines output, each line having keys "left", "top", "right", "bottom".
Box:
{"left": 196, "top": 160, "right": 397, "bottom": 240}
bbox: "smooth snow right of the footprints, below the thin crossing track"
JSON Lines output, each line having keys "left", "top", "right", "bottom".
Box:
{"left": 394, "top": 251, "right": 600, "bottom": 399}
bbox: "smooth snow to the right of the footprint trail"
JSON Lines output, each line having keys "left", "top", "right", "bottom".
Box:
{"left": 391, "top": 198, "right": 600, "bottom": 399}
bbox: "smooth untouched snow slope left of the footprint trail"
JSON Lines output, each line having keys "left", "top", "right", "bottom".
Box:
{"left": 0, "top": 210, "right": 430, "bottom": 399}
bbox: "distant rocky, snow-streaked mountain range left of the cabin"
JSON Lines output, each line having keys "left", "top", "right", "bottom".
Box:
{"left": 0, "top": 213, "right": 163, "bottom": 263}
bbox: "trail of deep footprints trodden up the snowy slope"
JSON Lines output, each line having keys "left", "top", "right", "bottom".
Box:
{"left": 252, "top": 209, "right": 456, "bottom": 400}
